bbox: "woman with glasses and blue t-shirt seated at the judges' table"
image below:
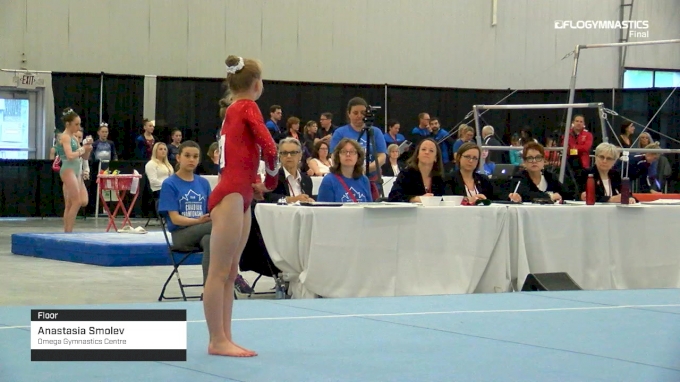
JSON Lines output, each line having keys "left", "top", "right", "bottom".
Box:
{"left": 316, "top": 138, "right": 373, "bottom": 203}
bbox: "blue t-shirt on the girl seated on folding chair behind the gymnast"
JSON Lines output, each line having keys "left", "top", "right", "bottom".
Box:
{"left": 158, "top": 174, "right": 210, "bottom": 232}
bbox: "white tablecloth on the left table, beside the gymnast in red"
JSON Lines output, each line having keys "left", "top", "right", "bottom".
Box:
{"left": 255, "top": 204, "right": 510, "bottom": 298}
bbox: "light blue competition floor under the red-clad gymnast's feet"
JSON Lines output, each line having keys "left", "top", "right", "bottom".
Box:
{"left": 0, "top": 289, "right": 680, "bottom": 382}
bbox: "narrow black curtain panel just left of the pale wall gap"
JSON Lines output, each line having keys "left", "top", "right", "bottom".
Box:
{"left": 101, "top": 74, "right": 144, "bottom": 159}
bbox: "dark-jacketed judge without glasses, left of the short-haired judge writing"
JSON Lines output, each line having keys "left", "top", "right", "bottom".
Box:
{"left": 444, "top": 142, "right": 522, "bottom": 205}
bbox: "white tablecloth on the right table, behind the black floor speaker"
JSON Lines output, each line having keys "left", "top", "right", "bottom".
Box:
{"left": 509, "top": 205, "right": 680, "bottom": 290}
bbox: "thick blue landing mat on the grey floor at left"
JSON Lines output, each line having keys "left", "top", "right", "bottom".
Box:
{"left": 12, "top": 232, "right": 202, "bottom": 267}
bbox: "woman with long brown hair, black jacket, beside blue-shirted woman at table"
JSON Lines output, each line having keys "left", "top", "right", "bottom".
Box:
{"left": 388, "top": 138, "right": 444, "bottom": 203}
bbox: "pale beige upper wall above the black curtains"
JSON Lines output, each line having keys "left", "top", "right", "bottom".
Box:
{"left": 0, "top": 0, "right": 680, "bottom": 89}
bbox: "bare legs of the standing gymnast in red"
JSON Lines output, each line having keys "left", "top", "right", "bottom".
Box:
{"left": 203, "top": 193, "right": 255, "bottom": 357}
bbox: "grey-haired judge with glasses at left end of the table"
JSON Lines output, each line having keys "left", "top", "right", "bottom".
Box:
{"left": 264, "top": 137, "right": 314, "bottom": 203}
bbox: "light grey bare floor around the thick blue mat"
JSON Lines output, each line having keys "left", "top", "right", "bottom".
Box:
{"left": 0, "top": 217, "right": 274, "bottom": 305}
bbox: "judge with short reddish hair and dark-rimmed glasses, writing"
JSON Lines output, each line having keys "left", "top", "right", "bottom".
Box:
{"left": 515, "top": 142, "right": 573, "bottom": 202}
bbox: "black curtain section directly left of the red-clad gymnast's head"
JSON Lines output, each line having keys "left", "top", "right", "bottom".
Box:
{"left": 154, "top": 77, "right": 224, "bottom": 153}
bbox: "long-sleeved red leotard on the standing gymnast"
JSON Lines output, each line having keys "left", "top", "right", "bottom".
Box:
{"left": 208, "top": 99, "right": 278, "bottom": 212}
